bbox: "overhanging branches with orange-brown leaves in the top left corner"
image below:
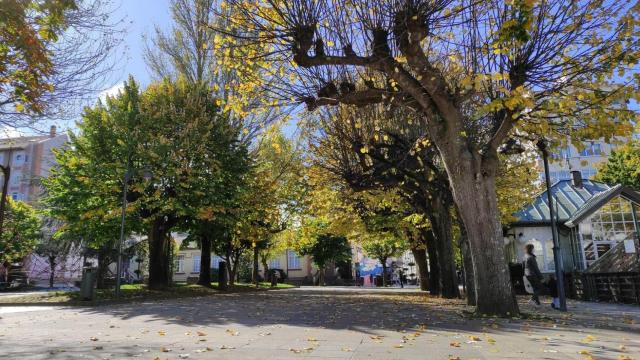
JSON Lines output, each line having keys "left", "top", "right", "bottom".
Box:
{"left": 0, "top": 0, "right": 122, "bottom": 128}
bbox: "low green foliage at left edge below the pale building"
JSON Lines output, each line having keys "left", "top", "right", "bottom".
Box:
{"left": 0, "top": 199, "right": 42, "bottom": 264}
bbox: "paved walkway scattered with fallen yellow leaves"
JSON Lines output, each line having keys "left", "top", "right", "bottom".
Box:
{"left": 0, "top": 288, "right": 640, "bottom": 360}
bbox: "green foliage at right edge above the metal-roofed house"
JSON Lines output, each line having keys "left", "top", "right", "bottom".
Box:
{"left": 596, "top": 140, "right": 640, "bottom": 190}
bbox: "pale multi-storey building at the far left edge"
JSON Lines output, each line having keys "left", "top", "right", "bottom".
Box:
{"left": 0, "top": 126, "right": 69, "bottom": 205}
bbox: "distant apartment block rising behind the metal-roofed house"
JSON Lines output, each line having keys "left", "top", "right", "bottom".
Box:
{"left": 538, "top": 140, "right": 617, "bottom": 183}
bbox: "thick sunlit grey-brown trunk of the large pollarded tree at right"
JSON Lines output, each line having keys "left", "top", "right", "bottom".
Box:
{"left": 443, "top": 152, "right": 519, "bottom": 316}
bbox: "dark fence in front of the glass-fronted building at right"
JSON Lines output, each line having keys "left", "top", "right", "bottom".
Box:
{"left": 567, "top": 272, "right": 640, "bottom": 305}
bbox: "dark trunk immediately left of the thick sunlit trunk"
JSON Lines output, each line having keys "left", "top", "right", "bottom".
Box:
{"left": 429, "top": 200, "right": 460, "bottom": 299}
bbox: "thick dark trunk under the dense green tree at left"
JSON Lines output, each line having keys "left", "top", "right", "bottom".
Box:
{"left": 148, "top": 217, "right": 171, "bottom": 290}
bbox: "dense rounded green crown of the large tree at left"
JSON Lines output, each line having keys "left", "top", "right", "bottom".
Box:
{"left": 44, "top": 79, "right": 248, "bottom": 258}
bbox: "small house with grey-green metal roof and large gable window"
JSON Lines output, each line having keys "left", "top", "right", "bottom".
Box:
{"left": 505, "top": 173, "right": 640, "bottom": 274}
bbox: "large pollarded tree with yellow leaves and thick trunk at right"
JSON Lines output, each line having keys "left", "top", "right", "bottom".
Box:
{"left": 220, "top": 0, "right": 640, "bottom": 315}
